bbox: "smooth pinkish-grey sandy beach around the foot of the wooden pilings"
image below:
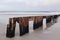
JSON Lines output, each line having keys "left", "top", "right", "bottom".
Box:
{"left": 0, "top": 12, "right": 60, "bottom": 40}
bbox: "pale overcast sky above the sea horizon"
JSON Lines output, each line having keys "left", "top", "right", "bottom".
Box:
{"left": 0, "top": 0, "right": 60, "bottom": 11}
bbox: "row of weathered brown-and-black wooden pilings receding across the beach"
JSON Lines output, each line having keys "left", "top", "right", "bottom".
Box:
{"left": 6, "top": 15, "right": 58, "bottom": 38}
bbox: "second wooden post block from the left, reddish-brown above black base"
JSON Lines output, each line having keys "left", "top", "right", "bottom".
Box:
{"left": 19, "top": 17, "right": 29, "bottom": 36}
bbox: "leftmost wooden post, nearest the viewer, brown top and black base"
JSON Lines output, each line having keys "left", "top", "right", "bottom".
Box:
{"left": 6, "top": 18, "right": 16, "bottom": 38}
